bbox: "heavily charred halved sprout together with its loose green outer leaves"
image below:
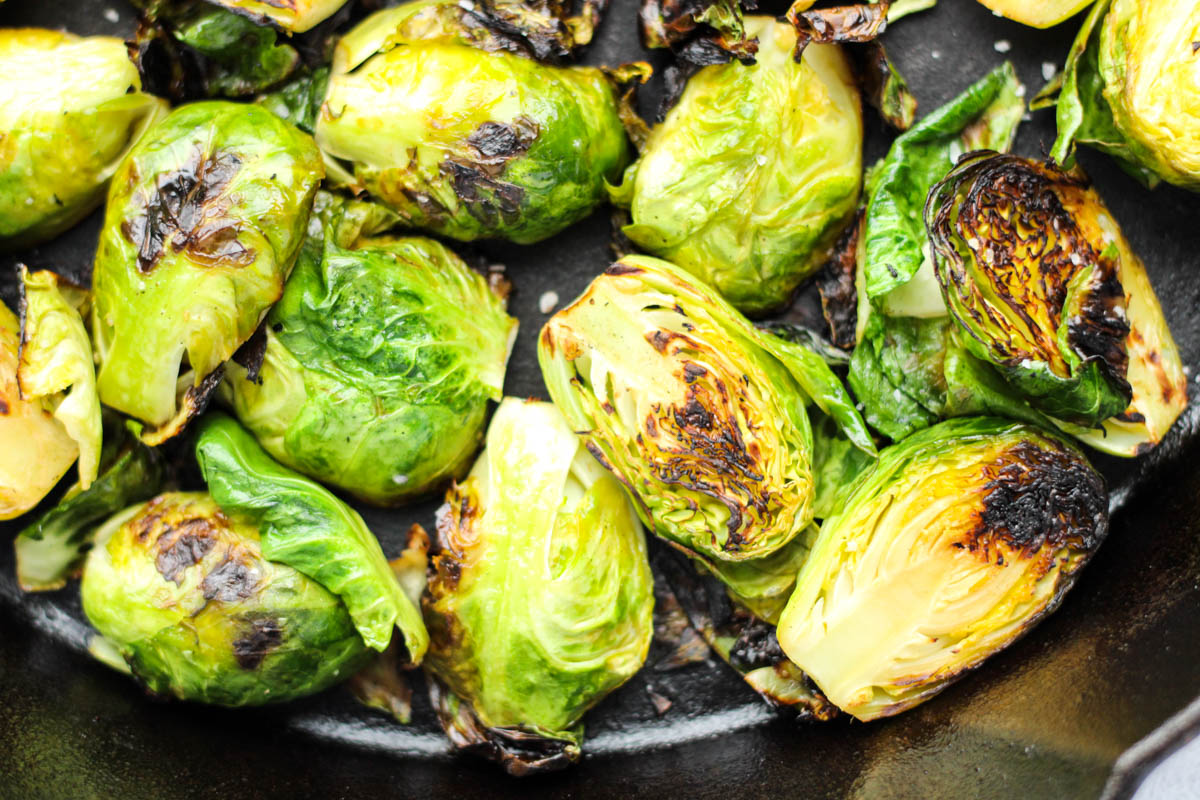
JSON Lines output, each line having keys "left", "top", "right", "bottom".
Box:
{"left": 850, "top": 61, "right": 1187, "bottom": 456}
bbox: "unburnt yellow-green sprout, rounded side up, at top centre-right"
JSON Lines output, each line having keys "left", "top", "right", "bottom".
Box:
{"left": 614, "top": 17, "right": 863, "bottom": 314}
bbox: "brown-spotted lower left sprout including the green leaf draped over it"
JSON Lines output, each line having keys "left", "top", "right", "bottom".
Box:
{"left": 80, "top": 415, "right": 428, "bottom": 705}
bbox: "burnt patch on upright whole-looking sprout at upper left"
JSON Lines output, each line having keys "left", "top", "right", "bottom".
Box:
{"left": 121, "top": 149, "right": 254, "bottom": 273}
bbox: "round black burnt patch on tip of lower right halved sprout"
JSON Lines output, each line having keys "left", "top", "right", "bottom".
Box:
{"left": 966, "top": 441, "right": 1109, "bottom": 561}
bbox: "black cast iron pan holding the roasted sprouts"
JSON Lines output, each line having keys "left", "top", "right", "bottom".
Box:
{"left": 0, "top": 0, "right": 1200, "bottom": 800}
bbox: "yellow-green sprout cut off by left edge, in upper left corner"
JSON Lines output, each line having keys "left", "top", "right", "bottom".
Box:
{"left": 0, "top": 28, "right": 167, "bottom": 249}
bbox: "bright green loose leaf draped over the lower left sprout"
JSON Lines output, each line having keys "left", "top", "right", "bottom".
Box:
{"left": 196, "top": 414, "right": 428, "bottom": 663}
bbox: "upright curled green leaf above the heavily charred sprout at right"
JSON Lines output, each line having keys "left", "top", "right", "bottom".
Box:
{"left": 863, "top": 61, "right": 1025, "bottom": 301}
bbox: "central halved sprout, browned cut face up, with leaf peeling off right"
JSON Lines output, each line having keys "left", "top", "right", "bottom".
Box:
{"left": 538, "top": 255, "right": 875, "bottom": 561}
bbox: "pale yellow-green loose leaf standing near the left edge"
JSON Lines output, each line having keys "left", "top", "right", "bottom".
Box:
{"left": 17, "top": 265, "right": 103, "bottom": 489}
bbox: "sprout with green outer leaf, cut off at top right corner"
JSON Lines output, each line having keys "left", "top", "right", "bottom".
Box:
{"left": 1051, "top": 0, "right": 1200, "bottom": 191}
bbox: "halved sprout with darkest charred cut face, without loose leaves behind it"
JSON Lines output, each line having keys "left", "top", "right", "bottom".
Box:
{"left": 926, "top": 154, "right": 1187, "bottom": 455}
